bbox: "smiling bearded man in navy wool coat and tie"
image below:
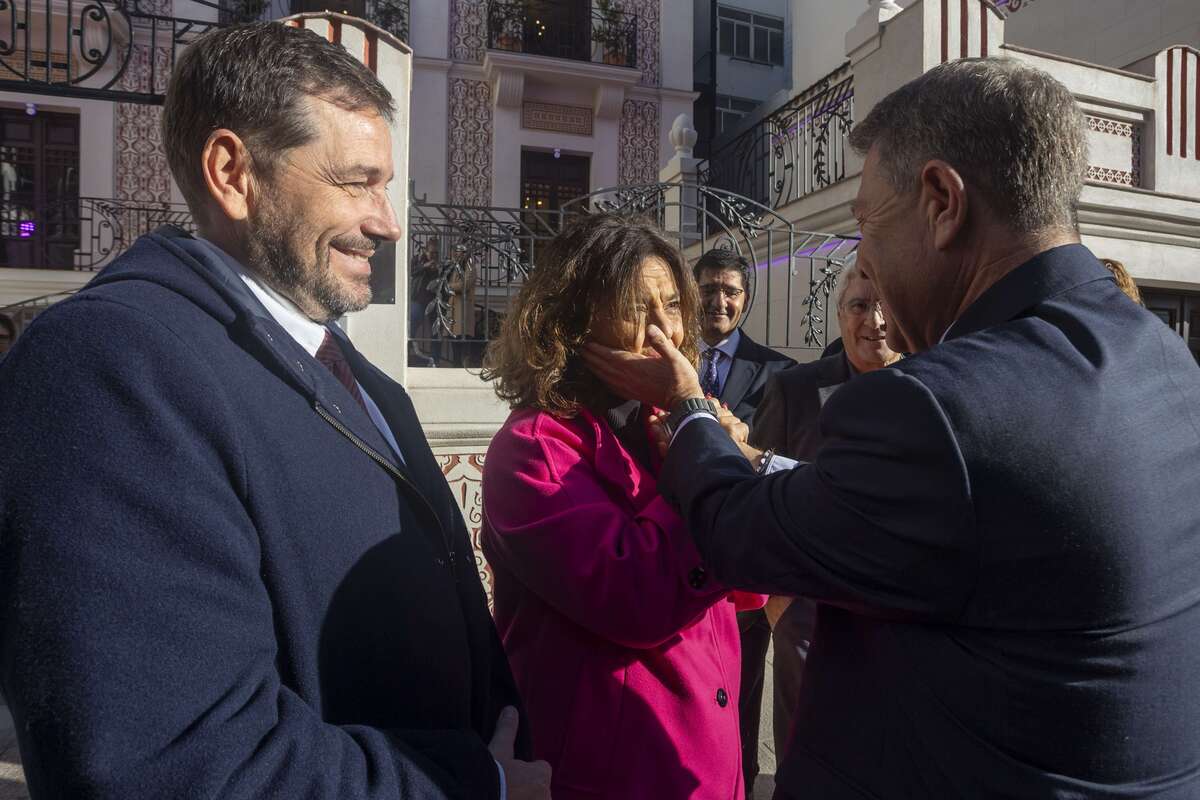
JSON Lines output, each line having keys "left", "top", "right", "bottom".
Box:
{"left": 0, "top": 23, "right": 548, "bottom": 800}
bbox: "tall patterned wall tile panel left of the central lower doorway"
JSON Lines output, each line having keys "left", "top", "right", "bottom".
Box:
{"left": 446, "top": 78, "right": 492, "bottom": 205}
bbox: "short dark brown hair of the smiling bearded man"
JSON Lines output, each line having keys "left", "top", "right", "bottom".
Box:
{"left": 162, "top": 22, "right": 395, "bottom": 218}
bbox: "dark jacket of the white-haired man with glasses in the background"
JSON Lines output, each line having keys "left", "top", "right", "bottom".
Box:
{"left": 750, "top": 353, "right": 853, "bottom": 461}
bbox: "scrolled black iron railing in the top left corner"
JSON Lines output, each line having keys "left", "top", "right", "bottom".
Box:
{"left": 0, "top": 0, "right": 238, "bottom": 104}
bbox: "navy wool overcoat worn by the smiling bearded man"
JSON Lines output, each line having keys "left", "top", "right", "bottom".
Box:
{"left": 0, "top": 229, "right": 529, "bottom": 800}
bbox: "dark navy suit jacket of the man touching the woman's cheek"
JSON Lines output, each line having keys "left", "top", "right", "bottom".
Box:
{"left": 659, "top": 245, "right": 1200, "bottom": 800}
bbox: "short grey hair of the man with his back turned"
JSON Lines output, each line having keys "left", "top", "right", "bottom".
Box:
{"left": 850, "top": 59, "right": 1087, "bottom": 233}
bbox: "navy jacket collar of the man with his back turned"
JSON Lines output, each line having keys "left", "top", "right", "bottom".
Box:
{"left": 943, "top": 245, "right": 1112, "bottom": 342}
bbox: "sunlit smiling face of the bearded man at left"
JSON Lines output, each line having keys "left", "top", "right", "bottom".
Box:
{"left": 246, "top": 97, "right": 401, "bottom": 321}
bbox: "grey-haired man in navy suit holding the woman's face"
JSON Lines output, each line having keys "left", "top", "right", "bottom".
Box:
{"left": 588, "top": 59, "right": 1200, "bottom": 800}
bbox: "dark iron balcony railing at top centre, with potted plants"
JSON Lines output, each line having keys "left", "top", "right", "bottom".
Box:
{"left": 487, "top": 0, "right": 637, "bottom": 67}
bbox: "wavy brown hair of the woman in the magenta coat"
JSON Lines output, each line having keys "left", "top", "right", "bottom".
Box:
{"left": 484, "top": 213, "right": 700, "bottom": 416}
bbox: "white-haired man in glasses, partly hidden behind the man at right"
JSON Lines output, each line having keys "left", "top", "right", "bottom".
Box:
{"left": 749, "top": 255, "right": 900, "bottom": 759}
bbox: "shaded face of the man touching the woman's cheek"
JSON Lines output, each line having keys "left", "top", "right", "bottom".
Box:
{"left": 842, "top": 146, "right": 938, "bottom": 351}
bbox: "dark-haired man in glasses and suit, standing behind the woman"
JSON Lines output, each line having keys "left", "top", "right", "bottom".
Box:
{"left": 692, "top": 248, "right": 796, "bottom": 794}
